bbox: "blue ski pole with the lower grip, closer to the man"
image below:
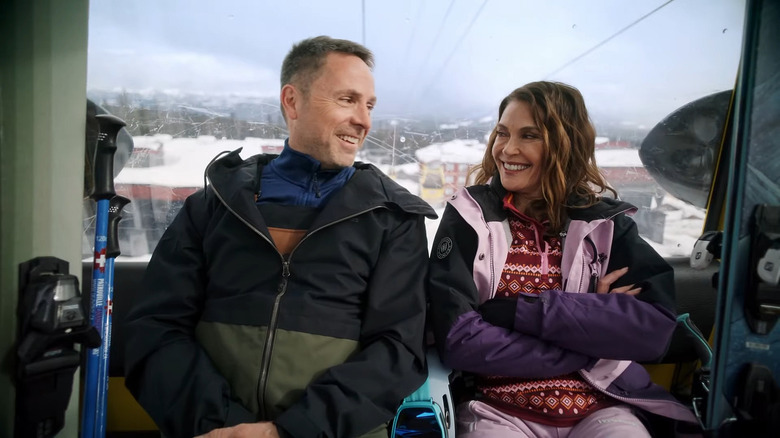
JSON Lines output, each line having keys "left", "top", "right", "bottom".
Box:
{"left": 95, "top": 195, "right": 130, "bottom": 437}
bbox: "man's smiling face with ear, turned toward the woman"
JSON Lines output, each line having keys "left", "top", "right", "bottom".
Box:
{"left": 282, "top": 53, "right": 376, "bottom": 169}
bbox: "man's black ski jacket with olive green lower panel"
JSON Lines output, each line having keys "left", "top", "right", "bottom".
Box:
{"left": 125, "top": 151, "right": 436, "bottom": 437}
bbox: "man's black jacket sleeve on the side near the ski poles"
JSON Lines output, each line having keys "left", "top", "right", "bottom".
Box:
{"left": 125, "top": 191, "right": 256, "bottom": 437}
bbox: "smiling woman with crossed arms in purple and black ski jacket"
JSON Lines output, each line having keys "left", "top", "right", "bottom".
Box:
{"left": 430, "top": 82, "right": 696, "bottom": 437}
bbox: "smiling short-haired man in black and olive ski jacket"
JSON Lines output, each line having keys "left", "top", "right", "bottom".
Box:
{"left": 126, "top": 36, "right": 435, "bottom": 437}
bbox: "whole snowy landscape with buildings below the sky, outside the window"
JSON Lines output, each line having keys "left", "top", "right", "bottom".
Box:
{"left": 84, "top": 91, "right": 701, "bottom": 257}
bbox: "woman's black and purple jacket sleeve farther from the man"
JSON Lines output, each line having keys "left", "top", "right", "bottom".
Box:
{"left": 515, "top": 215, "right": 676, "bottom": 361}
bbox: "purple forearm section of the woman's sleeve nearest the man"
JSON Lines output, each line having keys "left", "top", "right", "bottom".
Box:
{"left": 443, "top": 311, "right": 595, "bottom": 378}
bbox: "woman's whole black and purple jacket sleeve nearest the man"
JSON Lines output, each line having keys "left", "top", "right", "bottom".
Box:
{"left": 428, "top": 205, "right": 594, "bottom": 377}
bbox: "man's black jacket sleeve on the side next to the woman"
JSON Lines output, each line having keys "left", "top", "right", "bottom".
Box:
{"left": 274, "top": 213, "right": 428, "bottom": 437}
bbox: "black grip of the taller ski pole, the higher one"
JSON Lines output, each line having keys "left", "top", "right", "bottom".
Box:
{"left": 90, "top": 114, "right": 125, "bottom": 201}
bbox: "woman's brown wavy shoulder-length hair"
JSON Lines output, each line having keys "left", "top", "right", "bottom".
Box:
{"left": 472, "top": 81, "right": 617, "bottom": 233}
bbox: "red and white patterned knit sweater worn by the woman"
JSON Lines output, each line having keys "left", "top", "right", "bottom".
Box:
{"left": 477, "top": 193, "right": 614, "bottom": 427}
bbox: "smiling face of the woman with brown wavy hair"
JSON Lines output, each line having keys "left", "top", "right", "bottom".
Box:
{"left": 492, "top": 100, "right": 544, "bottom": 200}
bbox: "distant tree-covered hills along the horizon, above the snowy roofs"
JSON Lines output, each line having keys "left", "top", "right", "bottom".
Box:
{"left": 88, "top": 90, "right": 651, "bottom": 164}
